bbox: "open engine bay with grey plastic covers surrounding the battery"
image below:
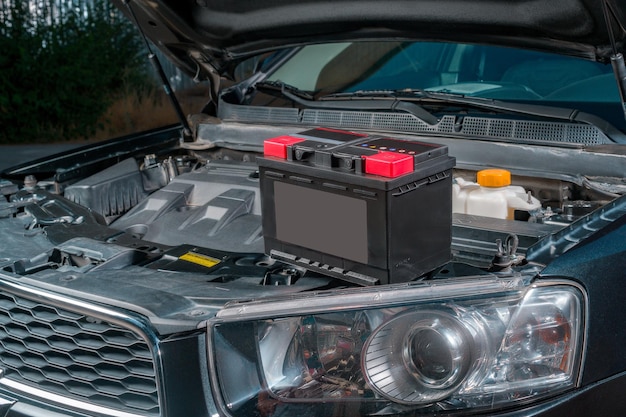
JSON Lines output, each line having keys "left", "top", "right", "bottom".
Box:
{"left": 0, "top": 123, "right": 625, "bottom": 319}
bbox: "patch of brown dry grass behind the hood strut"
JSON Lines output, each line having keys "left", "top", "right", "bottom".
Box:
{"left": 89, "top": 85, "right": 209, "bottom": 141}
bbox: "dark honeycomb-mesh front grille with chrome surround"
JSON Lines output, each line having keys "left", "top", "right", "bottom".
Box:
{"left": 0, "top": 292, "right": 160, "bottom": 416}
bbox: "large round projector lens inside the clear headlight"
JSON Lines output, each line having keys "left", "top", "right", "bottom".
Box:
{"left": 362, "top": 310, "right": 472, "bottom": 404}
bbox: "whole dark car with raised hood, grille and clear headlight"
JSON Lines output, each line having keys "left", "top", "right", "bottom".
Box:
{"left": 0, "top": 0, "right": 626, "bottom": 417}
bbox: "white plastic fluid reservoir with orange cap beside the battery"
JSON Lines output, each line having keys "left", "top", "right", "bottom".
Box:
{"left": 452, "top": 169, "right": 541, "bottom": 220}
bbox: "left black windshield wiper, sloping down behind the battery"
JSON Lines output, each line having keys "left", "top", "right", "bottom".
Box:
{"left": 255, "top": 81, "right": 439, "bottom": 126}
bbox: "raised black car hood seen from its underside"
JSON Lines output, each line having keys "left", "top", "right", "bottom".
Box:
{"left": 112, "top": 0, "right": 626, "bottom": 79}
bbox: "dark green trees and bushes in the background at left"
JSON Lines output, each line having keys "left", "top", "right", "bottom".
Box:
{"left": 0, "top": 0, "right": 153, "bottom": 143}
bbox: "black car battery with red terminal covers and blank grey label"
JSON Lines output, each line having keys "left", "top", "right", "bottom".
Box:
{"left": 258, "top": 129, "right": 455, "bottom": 285}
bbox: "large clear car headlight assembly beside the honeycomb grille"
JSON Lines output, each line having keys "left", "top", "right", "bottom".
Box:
{"left": 209, "top": 278, "right": 584, "bottom": 416}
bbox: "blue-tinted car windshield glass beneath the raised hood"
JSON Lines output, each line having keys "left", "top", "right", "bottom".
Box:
{"left": 260, "top": 42, "right": 625, "bottom": 128}
